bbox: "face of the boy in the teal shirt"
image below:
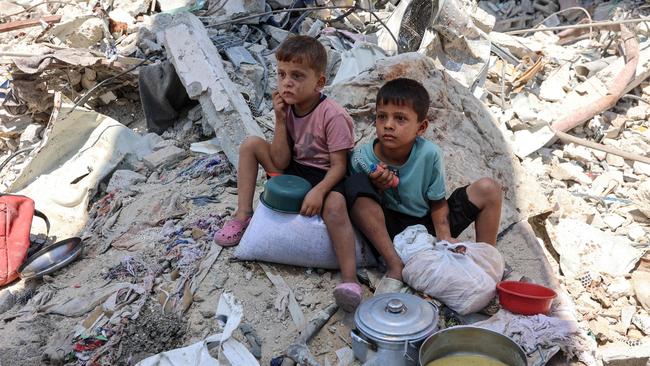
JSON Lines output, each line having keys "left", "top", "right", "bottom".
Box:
{"left": 375, "top": 103, "right": 429, "bottom": 149}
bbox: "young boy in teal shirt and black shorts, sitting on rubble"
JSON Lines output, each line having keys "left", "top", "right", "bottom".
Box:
{"left": 345, "top": 78, "right": 502, "bottom": 293}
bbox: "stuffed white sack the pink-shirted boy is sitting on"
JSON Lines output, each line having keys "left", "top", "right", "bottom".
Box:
{"left": 235, "top": 204, "right": 377, "bottom": 269}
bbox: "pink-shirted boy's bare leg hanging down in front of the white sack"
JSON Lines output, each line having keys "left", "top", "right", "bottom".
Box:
{"left": 323, "top": 192, "right": 357, "bottom": 282}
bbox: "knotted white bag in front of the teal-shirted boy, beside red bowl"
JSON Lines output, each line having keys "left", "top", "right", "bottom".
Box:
{"left": 394, "top": 225, "right": 505, "bottom": 315}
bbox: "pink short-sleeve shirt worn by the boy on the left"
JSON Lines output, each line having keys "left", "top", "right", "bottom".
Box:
{"left": 287, "top": 96, "right": 354, "bottom": 170}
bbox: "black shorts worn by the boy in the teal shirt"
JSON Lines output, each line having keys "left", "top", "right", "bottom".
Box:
{"left": 345, "top": 173, "right": 479, "bottom": 240}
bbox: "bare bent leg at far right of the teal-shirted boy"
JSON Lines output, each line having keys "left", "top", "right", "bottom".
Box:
{"left": 467, "top": 178, "right": 503, "bottom": 245}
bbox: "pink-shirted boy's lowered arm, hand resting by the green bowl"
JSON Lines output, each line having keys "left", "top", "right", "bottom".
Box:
{"left": 300, "top": 150, "right": 348, "bottom": 216}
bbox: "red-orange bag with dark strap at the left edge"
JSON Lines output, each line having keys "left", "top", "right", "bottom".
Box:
{"left": 0, "top": 195, "right": 50, "bottom": 286}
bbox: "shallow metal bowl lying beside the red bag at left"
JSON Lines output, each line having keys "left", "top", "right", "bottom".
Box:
{"left": 18, "top": 238, "right": 83, "bottom": 279}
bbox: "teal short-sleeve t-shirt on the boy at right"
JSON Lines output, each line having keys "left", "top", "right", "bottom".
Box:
{"left": 350, "top": 137, "right": 446, "bottom": 217}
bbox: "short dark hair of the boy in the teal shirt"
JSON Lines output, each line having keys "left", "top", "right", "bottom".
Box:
{"left": 377, "top": 78, "right": 431, "bottom": 122}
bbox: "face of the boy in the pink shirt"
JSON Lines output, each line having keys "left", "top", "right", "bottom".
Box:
{"left": 278, "top": 61, "right": 325, "bottom": 105}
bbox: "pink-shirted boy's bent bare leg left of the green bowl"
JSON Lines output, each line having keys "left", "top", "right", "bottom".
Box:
{"left": 235, "top": 136, "right": 280, "bottom": 220}
